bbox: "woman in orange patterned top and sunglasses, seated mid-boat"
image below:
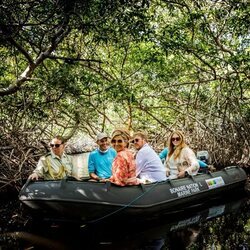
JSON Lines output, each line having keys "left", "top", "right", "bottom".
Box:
{"left": 110, "top": 129, "right": 139, "bottom": 186}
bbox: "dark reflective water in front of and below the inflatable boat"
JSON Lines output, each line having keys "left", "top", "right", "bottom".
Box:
{"left": 0, "top": 193, "right": 250, "bottom": 250}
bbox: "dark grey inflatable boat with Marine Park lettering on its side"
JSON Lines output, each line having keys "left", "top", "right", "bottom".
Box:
{"left": 19, "top": 166, "right": 247, "bottom": 223}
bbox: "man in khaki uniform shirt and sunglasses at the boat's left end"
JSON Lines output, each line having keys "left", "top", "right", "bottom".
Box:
{"left": 29, "top": 136, "right": 73, "bottom": 180}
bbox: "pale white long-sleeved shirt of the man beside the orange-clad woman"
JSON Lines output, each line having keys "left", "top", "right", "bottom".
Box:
{"left": 135, "top": 143, "right": 166, "bottom": 183}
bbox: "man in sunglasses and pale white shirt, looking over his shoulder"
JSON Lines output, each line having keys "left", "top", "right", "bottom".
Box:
{"left": 131, "top": 132, "right": 166, "bottom": 183}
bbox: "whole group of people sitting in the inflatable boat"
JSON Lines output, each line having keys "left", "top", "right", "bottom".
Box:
{"left": 29, "top": 129, "right": 204, "bottom": 186}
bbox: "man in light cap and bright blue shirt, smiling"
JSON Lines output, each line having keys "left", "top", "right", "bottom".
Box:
{"left": 88, "top": 133, "right": 116, "bottom": 181}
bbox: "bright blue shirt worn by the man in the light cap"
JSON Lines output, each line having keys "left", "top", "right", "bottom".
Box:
{"left": 88, "top": 147, "right": 116, "bottom": 179}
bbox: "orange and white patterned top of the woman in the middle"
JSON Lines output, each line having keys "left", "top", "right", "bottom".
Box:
{"left": 110, "top": 149, "right": 139, "bottom": 186}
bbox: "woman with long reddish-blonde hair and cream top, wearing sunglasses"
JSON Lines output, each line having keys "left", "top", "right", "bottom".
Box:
{"left": 166, "top": 130, "right": 199, "bottom": 179}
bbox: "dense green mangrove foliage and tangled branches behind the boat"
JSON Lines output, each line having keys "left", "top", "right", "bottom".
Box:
{"left": 0, "top": 0, "right": 250, "bottom": 189}
